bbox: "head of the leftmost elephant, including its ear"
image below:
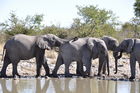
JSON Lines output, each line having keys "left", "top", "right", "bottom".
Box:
{"left": 36, "top": 34, "right": 67, "bottom": 50}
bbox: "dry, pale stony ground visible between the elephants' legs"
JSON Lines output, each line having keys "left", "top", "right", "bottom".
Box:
{"left": 0, "top": 46, "right": 140, "bottom": 79}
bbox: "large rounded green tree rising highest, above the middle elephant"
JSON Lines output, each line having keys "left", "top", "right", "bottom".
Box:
{"left": 71, "top": 5, "right": 116, "bottom": 37}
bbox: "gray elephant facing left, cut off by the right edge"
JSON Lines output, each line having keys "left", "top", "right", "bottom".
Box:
{"left": 116, "top": 39, "right": 140, "bottom": 79}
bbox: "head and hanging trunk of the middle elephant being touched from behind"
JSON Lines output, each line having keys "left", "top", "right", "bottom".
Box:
{"left": 87, "top": 38, "right": 110, "bottom": 75}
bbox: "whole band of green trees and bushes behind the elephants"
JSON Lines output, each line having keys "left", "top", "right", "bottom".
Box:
{"left": 0, "top": 5, "right": 137, "bottom": 42}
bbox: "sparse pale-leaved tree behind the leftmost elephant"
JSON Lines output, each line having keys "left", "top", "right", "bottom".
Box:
{"left": 0, "top": 12, "right": 43, "bottom": 36}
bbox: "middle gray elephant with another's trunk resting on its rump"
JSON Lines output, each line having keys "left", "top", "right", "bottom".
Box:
{"left": 52, "top": 37, "right": 109, "bottom": 77}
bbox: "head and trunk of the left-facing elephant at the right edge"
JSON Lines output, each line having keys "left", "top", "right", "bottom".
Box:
{"left": 114, "top": 39, "right": 135, "bottom": 74}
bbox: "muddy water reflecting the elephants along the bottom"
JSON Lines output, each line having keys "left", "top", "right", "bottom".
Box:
{"left": 0, "top": 78, "right": 140, "bottom": 93}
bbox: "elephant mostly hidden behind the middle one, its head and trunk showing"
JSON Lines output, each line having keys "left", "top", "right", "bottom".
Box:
{"left": 101, "top": 36, "right": 119, "bottom": 74}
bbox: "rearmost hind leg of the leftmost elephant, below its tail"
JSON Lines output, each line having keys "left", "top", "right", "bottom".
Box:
{"left": 1, "top": 54, "right": 11, "bottom": 77}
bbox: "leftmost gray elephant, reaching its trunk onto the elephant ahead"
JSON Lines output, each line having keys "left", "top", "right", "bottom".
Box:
{"left": 1, "top": 34, "right": 67, "bottom": 77}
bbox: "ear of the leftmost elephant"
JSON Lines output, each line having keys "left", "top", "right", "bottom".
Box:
{"left": 36, "top": 36, "right": 51, "bottom": 50}
